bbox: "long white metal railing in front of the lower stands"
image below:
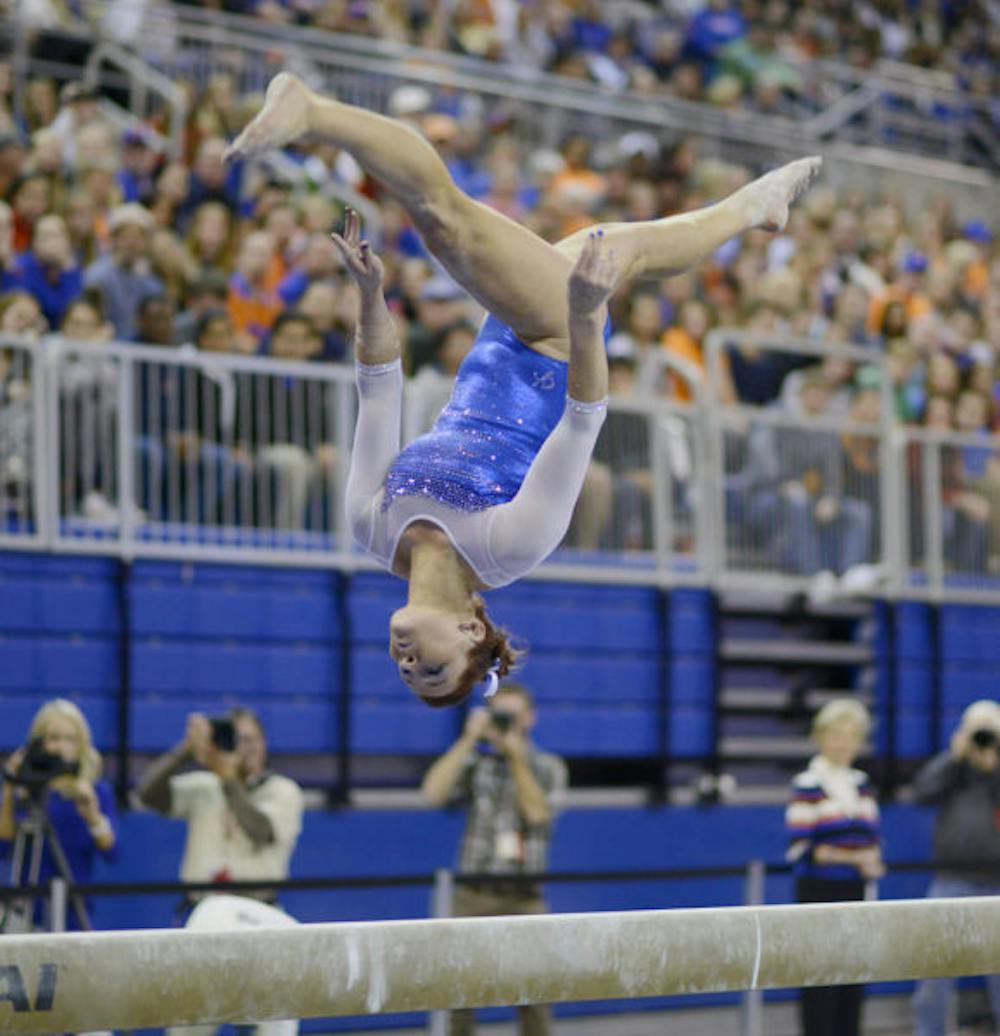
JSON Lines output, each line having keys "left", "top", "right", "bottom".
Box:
{"left": 0, "top": 329, "right": 1000, "bottom": 601}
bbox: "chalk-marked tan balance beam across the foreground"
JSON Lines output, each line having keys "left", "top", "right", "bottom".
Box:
{"left": 0, "top": 897, "right": 1000, "bottom": 1036}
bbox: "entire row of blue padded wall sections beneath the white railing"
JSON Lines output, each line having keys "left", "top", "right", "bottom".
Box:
{"left": 0, "top": 553, "right": 1000, "bottom": 759}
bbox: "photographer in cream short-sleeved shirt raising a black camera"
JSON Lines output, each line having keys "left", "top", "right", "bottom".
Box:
{"left": 138, "top": 709, "right": 303, "bottom": 902}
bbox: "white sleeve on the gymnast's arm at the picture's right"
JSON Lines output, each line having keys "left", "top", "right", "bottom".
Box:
{"left": 489, "top": 398, "right": 607, "bottom": 578}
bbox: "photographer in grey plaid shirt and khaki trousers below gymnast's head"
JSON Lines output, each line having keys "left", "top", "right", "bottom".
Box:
{"left": 422, "top": 684, "right": 567, "bottom": 1036}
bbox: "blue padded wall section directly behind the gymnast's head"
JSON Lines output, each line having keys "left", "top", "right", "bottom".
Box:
{"left": 350, "top": 573, "right": 675, "bottom": 756}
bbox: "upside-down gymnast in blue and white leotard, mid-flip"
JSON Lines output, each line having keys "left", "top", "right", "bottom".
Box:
{"left": 229, "top": 73, "right": 821, "bottom": 707}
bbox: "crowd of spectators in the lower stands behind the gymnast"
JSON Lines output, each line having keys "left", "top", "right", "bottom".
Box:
{"left": 0, "top": 28, "right": 1000, "bottom": 573}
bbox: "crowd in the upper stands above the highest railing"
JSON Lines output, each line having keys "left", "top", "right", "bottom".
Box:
{"left": 159, "top": 0, "right": 1000, "bottom": 114}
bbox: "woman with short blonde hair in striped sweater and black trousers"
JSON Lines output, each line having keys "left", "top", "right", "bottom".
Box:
{"left": 784, "top": 698, "right": 885, "bottom": 1036}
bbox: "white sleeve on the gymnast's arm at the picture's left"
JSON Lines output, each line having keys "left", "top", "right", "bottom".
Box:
{"left": 346, "top": 359, "right": 403, "bottom": 550}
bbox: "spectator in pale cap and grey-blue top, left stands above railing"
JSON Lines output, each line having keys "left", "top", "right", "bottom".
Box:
{"left": 84, "top": 202, "right": 164, "bottom": 342}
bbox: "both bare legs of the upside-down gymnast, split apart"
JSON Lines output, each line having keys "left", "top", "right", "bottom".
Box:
{"left": 225, "top": 73, "right": 820, "bottom": 358}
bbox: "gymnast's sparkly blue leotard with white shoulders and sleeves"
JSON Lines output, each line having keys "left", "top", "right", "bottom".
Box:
{"left": 347, "top": 316, "right": 606, "bottom": 586}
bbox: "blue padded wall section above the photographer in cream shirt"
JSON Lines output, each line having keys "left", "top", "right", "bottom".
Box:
{"left": 128, "top": 562, "right": 343, "bottom": 752}
